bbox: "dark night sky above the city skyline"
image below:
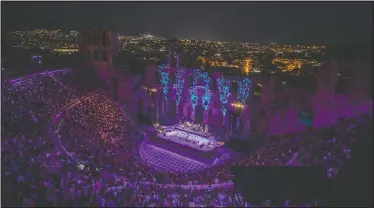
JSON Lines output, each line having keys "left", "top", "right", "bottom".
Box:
{"left": 1, "top": 2, "right": 373, "bottom": 45}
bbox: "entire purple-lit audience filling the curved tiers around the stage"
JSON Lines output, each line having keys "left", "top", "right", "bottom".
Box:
{"left": 2, "top": 68, "right": 372, "bottom": 207}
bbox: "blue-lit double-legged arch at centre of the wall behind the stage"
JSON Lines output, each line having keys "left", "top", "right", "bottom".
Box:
{"left": 191, "top": 69, "right": 211, "bottom": 110}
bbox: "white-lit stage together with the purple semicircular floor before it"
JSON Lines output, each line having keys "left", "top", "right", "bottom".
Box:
{"left": 140, "top": 123, "right": 230, "bottom": 173}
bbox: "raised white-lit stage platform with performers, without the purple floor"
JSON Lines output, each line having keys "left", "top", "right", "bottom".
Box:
{"left": 157, "top": 124, "right": 219, "bottom": 152}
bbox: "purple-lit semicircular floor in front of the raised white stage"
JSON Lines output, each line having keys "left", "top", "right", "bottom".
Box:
{"left": 139, "top": 121, "right": 245, "bottom": 173}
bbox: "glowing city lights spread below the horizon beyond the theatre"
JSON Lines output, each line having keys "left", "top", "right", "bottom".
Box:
{"left": 6, "top": 29, "right": 325, "bottom": 75}
